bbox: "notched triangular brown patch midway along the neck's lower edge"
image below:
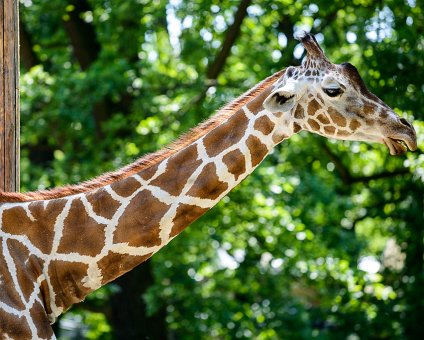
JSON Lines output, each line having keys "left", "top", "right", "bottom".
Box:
{"left": 187, "top": 163, "right": 228, "bottom": 199}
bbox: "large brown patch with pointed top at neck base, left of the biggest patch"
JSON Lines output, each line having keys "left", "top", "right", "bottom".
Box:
{"left": 57, "top": 198, "right": 106, "bottom": 256}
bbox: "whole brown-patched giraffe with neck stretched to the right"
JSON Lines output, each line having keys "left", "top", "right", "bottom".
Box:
{"left": 0, "top": 33, "right": 417, "bottom": 339}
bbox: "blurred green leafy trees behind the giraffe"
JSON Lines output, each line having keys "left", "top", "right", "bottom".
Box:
{"left": 20, "top": 0, "right": 424, "bottom": 340}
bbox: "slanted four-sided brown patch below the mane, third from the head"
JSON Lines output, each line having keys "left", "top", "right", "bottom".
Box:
{"left": 151, "top": 145, "right": 202, "bottom": 196}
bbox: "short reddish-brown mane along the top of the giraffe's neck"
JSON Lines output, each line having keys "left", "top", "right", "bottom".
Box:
{"left": 0, "top": 70, "right": 284, "bottom": 203}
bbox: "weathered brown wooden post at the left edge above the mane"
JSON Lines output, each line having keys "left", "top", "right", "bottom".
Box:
{"left": 0, "top": 0, "right": 19, "bottom": 191}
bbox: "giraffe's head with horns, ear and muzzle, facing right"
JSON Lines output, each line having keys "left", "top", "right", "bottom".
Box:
{"left": 263, "top": 34, "right": 417, "bottom": 155}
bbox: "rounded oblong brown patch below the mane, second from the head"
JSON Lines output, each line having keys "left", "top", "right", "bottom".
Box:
{"left": 203, "top": 111, "right": 249, "bottom": 157}
